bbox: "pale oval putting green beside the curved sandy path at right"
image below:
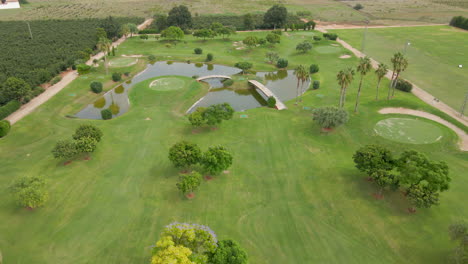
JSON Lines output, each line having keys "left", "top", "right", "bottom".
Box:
{"left": 374, "top": 118, "right": 442, "bottom": 144}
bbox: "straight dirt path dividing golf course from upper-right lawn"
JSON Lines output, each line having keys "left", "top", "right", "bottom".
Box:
{"left": 317, "top": 26, "right": 468, "bottom": 126}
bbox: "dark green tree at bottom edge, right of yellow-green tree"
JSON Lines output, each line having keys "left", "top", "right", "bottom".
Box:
{"left": 209, "top": 240, "right": 248, "bottom": 264}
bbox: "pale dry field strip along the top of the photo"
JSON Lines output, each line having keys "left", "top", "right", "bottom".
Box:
{"left": 0, "top": 0, "right": 468, "bottom": 24}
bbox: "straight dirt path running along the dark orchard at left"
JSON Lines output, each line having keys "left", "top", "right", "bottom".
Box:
{"left": 5, "top": 19, "right": 153, "bottom": 124}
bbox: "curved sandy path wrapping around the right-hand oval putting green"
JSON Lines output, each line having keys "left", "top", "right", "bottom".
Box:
{"left": 379, "top": 107, "right": 468, "bottom": 151}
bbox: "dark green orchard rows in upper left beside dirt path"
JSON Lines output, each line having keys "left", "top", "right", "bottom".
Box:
{"left": 0, "top": 18, "right": 143, "bottom": 87}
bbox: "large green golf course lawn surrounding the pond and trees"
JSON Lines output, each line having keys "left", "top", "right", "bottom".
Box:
{"left": 0, "top": 32, "right": 468, "bottom": 264}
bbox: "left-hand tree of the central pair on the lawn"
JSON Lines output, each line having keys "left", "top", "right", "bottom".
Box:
{"left": 169, "top": 141, "right": 202, "bottom": 168}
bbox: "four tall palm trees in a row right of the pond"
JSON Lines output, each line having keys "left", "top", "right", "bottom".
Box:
{"left": 336, "top": 52, "right": 408, "bottom": 113}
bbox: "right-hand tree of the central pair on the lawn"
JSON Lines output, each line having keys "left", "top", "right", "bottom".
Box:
{"left": 201, "top": 146, "right": 232, "bottom": 175}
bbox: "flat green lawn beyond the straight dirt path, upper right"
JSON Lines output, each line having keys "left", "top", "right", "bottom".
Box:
{"left": 333, "top": 26, "right": 468, "bottom": 114}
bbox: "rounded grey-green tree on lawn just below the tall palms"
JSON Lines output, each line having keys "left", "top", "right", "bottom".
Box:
{"left": 313, "top": 106, "right": 349, "bottom": 130}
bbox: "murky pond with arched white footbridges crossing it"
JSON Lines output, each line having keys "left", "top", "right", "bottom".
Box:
{"left": 75, "top": 61, "right": 309, "bottom": 119}
